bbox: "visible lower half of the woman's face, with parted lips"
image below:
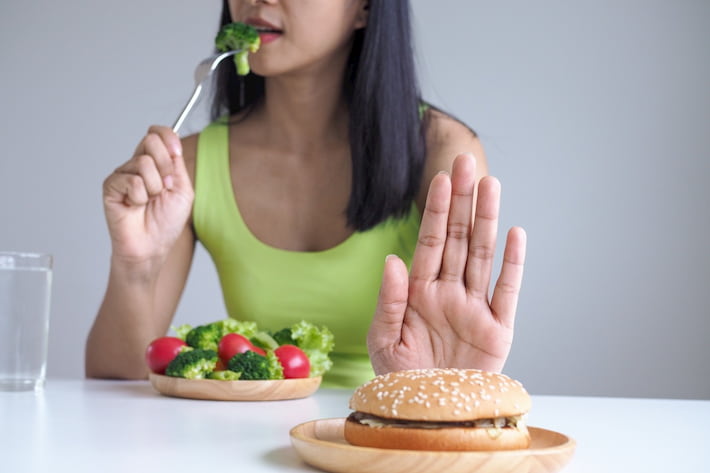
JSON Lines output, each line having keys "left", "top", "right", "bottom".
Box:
{"left": 229, "top": 0, "right": 367, "bottom": 76}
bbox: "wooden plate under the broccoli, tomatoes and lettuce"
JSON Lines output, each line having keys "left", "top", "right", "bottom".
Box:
{"left": 150, "top": 373, "right": 322, "bottom": 401}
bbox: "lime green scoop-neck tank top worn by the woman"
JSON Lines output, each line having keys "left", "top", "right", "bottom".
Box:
{"left": 193, "top": 123, "right": 420, "bottom": 388}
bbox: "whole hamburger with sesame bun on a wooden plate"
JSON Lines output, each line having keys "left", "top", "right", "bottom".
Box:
{"left": 344, "top": 368, "right": 531, "bottom": 451}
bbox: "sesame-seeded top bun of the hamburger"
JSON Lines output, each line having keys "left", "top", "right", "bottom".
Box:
{"left": 350, "top": 368, "right": 531, "bottom": 422}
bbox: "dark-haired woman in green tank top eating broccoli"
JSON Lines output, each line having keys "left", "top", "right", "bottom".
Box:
{"left": 86, "top": 0, "right": 525, "bottom": 387}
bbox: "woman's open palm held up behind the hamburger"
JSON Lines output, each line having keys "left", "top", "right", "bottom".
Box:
{"left": 367, "top": 155, "right": 526, "bottom": 374}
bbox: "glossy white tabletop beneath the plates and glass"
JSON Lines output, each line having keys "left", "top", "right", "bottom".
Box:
{"left": 0, "top": 379, "right": 710, "bottom": 473}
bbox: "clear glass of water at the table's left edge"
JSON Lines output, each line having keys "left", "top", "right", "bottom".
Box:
{"left": 0, "top": 251, "right": 52, "bottom": 391}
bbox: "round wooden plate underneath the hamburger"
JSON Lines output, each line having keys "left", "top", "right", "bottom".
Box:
{"left": 291, "top": 419, "right": 575, "bottom": 473}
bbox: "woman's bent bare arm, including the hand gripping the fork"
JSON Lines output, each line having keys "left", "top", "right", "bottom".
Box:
{"left": 85, "top": 127, "right": 195, "bottom": 379}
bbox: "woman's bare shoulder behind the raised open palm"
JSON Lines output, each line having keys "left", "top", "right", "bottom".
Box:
{"left": 417, "top": 107, "right": 488, "bottom": 209}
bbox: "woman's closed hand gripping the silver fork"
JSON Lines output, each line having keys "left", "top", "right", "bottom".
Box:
{"left": 103, "top": 126, "right": 194, "bottom": 264}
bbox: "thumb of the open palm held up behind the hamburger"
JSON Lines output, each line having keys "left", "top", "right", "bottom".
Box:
{"left": 368, "top": 255, "right": 409, "bottom": 353}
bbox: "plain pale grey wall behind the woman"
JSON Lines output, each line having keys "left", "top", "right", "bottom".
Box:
{"left": 0, "top": 0, "right": 710, "bottom": 399}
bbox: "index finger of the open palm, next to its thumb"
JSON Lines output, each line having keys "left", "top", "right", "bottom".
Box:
{"left": 411, "top": 173, "right": 451, "bottom": 281}
